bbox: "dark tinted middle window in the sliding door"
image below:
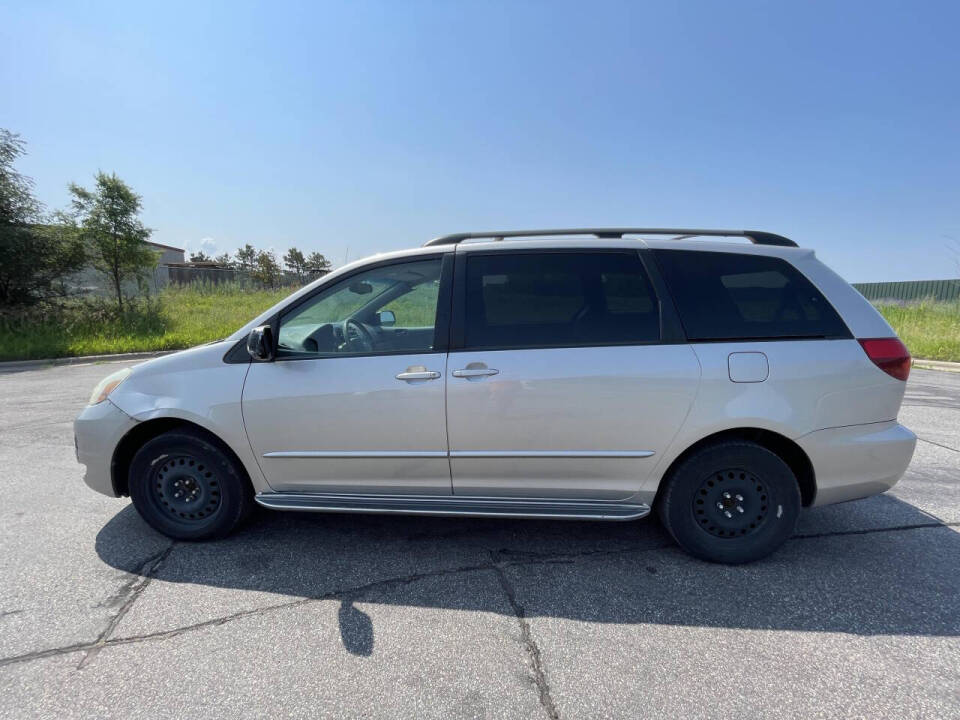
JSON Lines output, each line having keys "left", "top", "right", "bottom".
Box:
{"left": 464, "top": 253, "right": 660, "bottom": 348}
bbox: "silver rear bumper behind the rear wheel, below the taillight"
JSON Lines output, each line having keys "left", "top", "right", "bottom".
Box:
{"left": 797, "top": 420, "right": 917, "bottom": 506}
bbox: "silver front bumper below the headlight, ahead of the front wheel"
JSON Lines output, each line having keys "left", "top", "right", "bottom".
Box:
{"left": 73, "top": 399, "right": 137, "bottom": 497}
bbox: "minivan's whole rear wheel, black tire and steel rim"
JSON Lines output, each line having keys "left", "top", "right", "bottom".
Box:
{"left": 657, "top": 440, "right": 801, "bottom": 565}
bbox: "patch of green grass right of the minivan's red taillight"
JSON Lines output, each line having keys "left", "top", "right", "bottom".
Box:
{"left": 877, "top": 302, "right": 960, "bottom": 362}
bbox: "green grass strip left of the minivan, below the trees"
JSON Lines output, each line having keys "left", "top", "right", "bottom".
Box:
{"left": 0, "top": 285, "right": 292, "bottom": 360}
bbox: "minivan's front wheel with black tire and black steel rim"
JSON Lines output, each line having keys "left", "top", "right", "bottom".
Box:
{"left": 129, "top": 429, "right": 254, "bottom": 540}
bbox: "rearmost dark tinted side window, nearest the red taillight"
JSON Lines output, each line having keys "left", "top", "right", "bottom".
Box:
{"left": 654, "top": 250, "right": 850, "bottom": 341}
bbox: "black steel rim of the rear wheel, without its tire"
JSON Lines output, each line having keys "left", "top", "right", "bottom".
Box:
{"left": 693, "top": 468, "right": 770, "bottom": 538}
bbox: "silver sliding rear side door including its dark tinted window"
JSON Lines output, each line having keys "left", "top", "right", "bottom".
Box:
{"left": 447, "top": 248, "right": 700, "bottom": 500}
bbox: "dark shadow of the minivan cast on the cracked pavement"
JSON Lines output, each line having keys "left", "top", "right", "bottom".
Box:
{"left": 96, "top": 495, "right": 960, "bottom": 655}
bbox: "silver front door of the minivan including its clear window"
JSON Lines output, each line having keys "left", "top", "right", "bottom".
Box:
{"left": 243, "top": 256, "right": 452, "bottom": 495}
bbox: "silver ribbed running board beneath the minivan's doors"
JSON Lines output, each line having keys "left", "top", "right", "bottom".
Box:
{"left": 256, "top": 493, "right": 650, "bottom": 520}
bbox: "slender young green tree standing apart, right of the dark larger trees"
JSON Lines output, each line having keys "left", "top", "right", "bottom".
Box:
{"left": 70, "top": 172, "right": 158, "bottom": 310}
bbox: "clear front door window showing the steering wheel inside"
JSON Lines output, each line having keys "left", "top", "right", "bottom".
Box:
{"left": 277, "top": 258, "right": 441, "bottom": 357}
